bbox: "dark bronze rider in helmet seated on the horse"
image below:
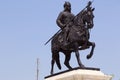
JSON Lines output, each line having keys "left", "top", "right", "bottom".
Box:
{"left": 56, "top": 2, "right": 74, "bottom": 46}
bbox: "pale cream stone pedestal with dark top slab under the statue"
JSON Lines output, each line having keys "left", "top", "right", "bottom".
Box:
{"left": 45, "top": 69, "right": 112, "bottom": 80}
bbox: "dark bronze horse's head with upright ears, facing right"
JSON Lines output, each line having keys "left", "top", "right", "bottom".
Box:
{"left": 82, "top": 7, "right": 95, "bottom": 28}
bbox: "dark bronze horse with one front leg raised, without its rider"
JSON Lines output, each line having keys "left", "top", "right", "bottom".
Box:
{"left": 51, "top": 7, "right": 95, "bottom": 74}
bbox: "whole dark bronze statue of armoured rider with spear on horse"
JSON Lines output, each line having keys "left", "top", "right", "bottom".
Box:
{"left": 47, "top": 1, "right": 95, "bottom": 74}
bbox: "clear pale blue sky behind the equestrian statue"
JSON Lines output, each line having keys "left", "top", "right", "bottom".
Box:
{"left": 0, "top": 0, "right": 120, "bottom": 80}
